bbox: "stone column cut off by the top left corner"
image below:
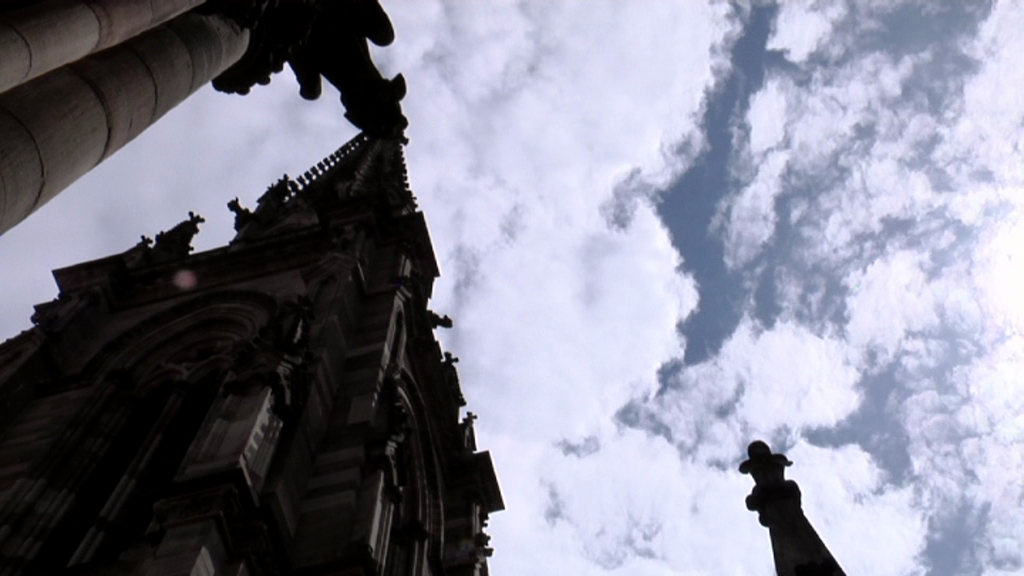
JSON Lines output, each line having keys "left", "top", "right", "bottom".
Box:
{"left": 0, "top": 0, "right": 205, "bottom": 92}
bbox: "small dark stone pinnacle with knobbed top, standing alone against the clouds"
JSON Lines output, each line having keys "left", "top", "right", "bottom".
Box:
{"left": 739, "top": 440, "right": 846, "bottom": 576}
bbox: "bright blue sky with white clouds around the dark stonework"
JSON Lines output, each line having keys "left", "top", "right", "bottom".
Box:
{"left": 0, "top": 0, "right": 1024, "bottom": 576}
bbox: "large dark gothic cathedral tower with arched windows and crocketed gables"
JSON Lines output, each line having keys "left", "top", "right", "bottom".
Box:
{"left": 0, "top": 135, "right": 503, "bottom": 576}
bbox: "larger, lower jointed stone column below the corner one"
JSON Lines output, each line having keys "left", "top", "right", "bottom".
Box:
{"left": 0, "top": 10, "right": 249, "bottom": 234}
